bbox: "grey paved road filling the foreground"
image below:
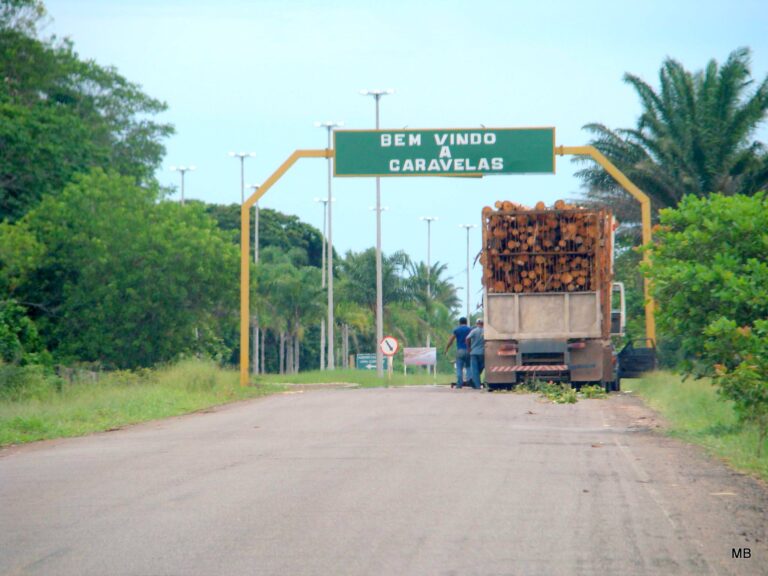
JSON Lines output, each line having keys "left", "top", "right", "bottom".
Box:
{"left": 0, "top": 387, "right": 768, "bottom": 576}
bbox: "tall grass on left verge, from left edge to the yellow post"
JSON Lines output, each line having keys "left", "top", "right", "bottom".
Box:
{"left": 0, "top": 359, "right": 284, "bottom": 446}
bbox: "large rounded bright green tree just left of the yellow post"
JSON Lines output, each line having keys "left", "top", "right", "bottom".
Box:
{"left": 19, "top": 170, "right": 238, "bottom": 367}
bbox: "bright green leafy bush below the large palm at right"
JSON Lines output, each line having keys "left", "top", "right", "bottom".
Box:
{"left": 646, "top": 193, "right": 768, "bottom": 370}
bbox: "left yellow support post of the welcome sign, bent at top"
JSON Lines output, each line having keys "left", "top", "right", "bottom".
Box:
{"left": 240, "top": 149, "right": 333, "bottom": 386}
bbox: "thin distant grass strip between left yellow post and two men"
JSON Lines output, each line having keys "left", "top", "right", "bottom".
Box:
{"left": 253, "top": 368, "right": 455, "bottom": 388}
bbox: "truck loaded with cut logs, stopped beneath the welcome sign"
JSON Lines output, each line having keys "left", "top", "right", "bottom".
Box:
{"left": 480, "top": 200, "right": 624, "bottom": 391}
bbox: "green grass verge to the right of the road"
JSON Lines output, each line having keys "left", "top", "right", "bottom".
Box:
{"left": 622, "top": 372, "right": 768, "bottom": 481}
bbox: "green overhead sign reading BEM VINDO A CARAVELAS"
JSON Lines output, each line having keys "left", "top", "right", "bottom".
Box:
{"left": 333, "top": 128, "right": 555, "bottom": 176}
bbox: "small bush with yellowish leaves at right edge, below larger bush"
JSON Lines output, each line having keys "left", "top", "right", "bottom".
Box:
{"left": 705, "top": 318, "right": 768, "bottom": 456}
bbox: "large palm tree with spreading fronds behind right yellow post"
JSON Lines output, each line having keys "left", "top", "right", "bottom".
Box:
{"left": 574, "top": 48, "right": 768, "bottom": 222}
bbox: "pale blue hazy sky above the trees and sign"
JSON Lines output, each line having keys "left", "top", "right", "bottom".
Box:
{"left": 46, "top": 0, "right": 768, "bottom": 316}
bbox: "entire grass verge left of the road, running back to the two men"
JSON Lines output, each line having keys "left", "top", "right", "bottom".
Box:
{"left": 0, "top": 359, "right": 451, "bottom": 446}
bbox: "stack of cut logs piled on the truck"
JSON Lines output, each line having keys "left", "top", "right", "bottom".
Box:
{"left": 480, "top": 200, "right": 609, "bottom": 293}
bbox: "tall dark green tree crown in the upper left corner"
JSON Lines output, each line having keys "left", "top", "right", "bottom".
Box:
{"left": 0, "top": 13, "right": 173, "bottom": 221}
